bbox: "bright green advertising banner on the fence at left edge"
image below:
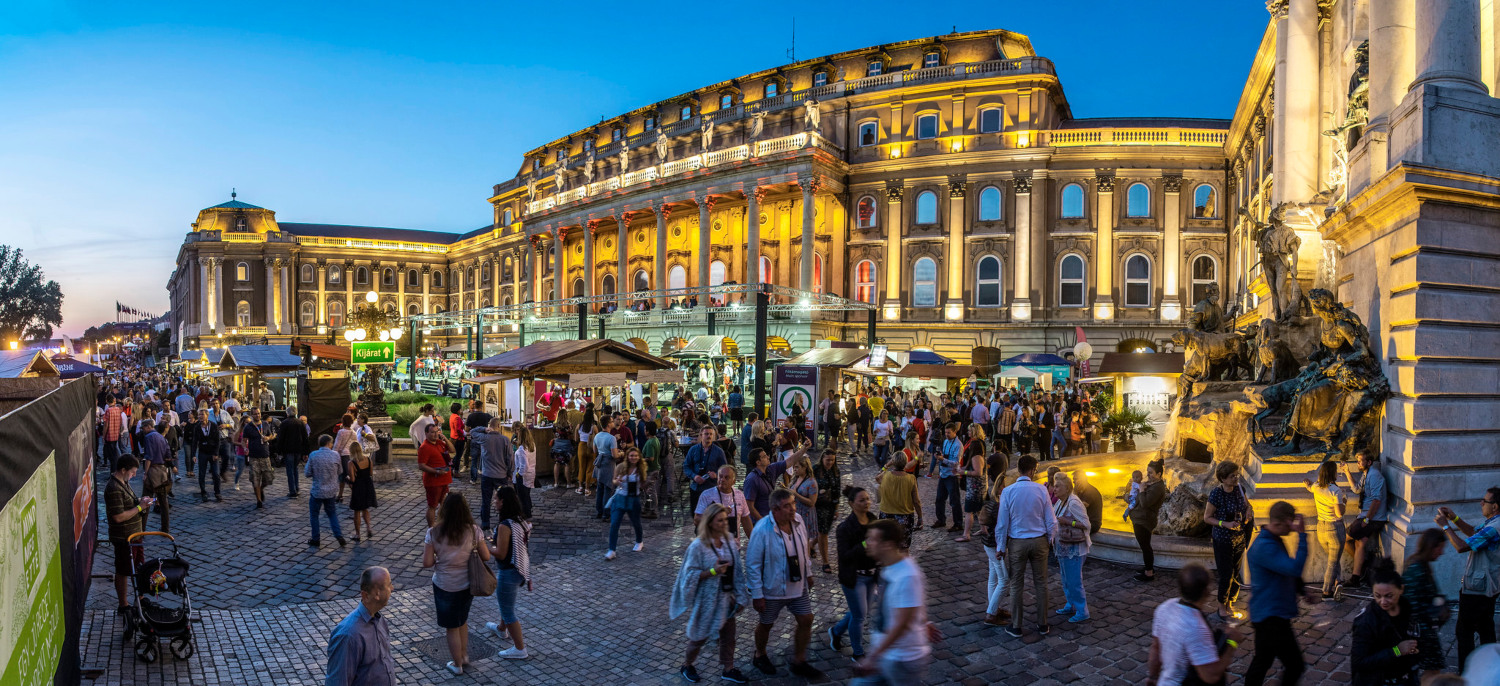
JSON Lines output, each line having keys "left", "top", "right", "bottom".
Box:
{"left": 0, "top": 453, "right": 66, "bottom": 686}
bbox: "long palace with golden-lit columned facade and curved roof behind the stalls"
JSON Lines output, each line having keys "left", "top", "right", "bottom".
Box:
{"left": 170, "top": 30, "right": 1250, "bottom": 362}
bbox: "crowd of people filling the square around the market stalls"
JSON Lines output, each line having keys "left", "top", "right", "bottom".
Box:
{"left": 90, "top": 352, "right": 1500, "bottom": 686}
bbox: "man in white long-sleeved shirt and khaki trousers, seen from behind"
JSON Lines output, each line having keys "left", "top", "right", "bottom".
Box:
{"left": 995, "top": 455, "right": 1058, "bottom": 638}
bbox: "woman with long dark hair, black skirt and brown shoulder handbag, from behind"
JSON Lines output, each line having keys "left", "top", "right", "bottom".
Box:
{"left": 422, "top": 492, "right": 491, "bottom": 674}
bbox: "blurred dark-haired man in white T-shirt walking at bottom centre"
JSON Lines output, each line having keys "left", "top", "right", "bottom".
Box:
{"left": 852, "top": 519, "right": 932, "bottom": 686}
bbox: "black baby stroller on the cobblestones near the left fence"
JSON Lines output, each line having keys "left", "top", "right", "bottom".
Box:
{"left": 125, "top": 531, "right": 195, "bottom": 662}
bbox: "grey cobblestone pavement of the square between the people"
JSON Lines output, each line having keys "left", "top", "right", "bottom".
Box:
{"left": 83, "top": 453, "right": 1374, "bottom": 686}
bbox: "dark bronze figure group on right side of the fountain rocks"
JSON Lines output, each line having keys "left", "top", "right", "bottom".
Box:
{"left": 1245, "top": 288, "right": 1391, "bottom": 458}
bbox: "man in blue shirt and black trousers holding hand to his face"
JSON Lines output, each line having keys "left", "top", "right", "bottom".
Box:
{"left": 1245, "top": 500, "right": 1308, "bottom": 686}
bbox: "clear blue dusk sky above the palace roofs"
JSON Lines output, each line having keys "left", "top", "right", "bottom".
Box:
{"left": 0, "top": 0, "right": 1268, "bottom": 335}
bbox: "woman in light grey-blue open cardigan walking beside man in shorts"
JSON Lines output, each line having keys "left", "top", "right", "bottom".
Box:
{"left": 668, "top": 503, "right": 750, "bottom": 683}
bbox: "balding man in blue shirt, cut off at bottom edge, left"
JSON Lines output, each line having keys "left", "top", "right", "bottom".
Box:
{"left": 323, "top": 567, "right": 396, "bottom": 686}
